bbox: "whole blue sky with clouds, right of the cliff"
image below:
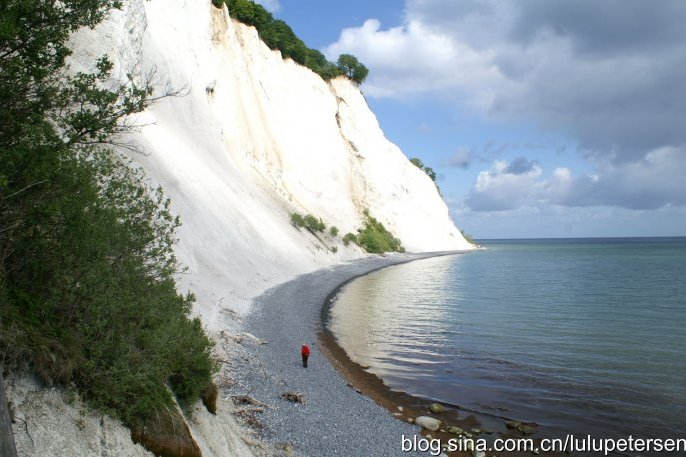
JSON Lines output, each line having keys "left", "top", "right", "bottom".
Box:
{"left": 260, "top": 0, "right": 686, "bottom": 238}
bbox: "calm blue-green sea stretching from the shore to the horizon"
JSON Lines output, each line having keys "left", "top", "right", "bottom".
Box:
{"left": 329, "top": 238, "right": 686, "bottom": 438}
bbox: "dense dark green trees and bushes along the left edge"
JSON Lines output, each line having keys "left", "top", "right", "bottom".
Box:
{"left": 0, "top": 0, "right": 215, "bottom": 432}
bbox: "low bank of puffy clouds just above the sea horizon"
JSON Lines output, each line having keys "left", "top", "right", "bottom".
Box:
{"left": 464, "top": 151, "right": 686, "bottom": 212}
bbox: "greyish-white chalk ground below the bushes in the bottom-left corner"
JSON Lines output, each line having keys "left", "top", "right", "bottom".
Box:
{"left": 7, "top": 377, "right": 260, "bottom": 457}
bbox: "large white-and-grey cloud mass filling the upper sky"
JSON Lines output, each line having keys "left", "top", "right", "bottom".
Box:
{"left": 327, "top": 0, "right": 686, "bottom": 162}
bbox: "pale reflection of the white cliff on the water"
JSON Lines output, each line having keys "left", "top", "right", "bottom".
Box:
{"left": 330, "top": 256, "right": 459, "bottom": 377}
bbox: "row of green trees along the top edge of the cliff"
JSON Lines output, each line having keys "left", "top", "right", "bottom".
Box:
{"left": 212, "top": 0, "right": 369, "bottom": 84}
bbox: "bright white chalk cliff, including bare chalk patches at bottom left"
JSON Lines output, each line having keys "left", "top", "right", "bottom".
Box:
{"left": 6, "top": 0, "right": 472, "bottom": 456}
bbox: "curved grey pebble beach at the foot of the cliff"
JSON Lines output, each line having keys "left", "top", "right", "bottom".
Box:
{"left": 229, "top": 251, "right": 564, "bottom": 456}
